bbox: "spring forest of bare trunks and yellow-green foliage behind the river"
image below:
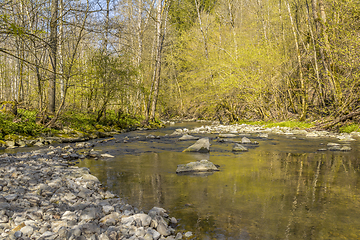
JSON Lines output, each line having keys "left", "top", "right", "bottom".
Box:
{"left": 0, "top": 0, "right": 360, "bottom": 131}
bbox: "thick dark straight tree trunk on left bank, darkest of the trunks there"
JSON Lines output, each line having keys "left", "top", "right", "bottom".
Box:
{"left": 48, "top": 0, "right": 59, "bottom": 113}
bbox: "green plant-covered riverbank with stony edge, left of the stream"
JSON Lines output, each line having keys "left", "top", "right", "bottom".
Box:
{"left": 0, "top": 109, "right": 163, "bottom": 149}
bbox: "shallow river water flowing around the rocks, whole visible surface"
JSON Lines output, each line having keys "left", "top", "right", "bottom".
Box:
{"left": 74, "top": 123, "right": 360, "bottom": 239}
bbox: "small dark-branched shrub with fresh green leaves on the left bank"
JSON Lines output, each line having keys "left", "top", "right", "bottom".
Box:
{"left": 74, "top": 50, "right": 137, "bottom": 116}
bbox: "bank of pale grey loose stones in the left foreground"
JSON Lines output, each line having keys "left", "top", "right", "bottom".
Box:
{"left": 0, "top": 145, "right": 184, "bottom": 240}
